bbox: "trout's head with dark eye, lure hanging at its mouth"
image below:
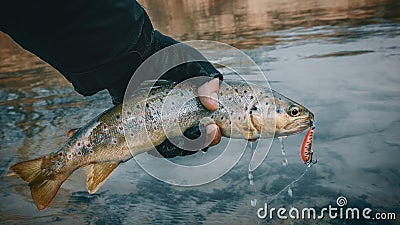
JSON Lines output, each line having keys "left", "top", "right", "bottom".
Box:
{"left": 249, "top": 91, "right": 314, "bottom": 138}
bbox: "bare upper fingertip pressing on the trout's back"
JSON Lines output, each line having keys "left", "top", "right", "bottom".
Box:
{"left": 197, "top": 78, "right": 219, "bottom": 110}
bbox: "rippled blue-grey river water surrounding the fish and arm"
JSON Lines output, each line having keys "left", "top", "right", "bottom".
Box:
{"left": 0, "top": 0, "right": 400, "bottom": 224}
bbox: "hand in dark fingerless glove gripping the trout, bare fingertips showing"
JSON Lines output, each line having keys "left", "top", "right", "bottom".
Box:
{"left": 108, "top": 31, "right": 222, "bottom": 158}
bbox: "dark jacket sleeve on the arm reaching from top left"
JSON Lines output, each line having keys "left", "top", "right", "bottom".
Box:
{"left": 0, "top": 0, "right": 222, "bottom": 103}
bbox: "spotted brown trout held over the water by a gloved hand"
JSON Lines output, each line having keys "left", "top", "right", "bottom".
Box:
{"left": 10, "top": 81, "right": 314, "bottom": 210}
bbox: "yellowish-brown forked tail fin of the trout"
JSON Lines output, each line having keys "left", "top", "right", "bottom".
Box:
{"left": 10, "top": 156, "right": 70, "bottom": 210}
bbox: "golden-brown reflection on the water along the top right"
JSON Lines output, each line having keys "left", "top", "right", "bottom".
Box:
{"left": 140, "top": 0, "right": 400, "bottom": 48}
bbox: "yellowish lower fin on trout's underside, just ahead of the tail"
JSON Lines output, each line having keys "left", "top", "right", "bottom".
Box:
{"left": 85, "top": 162, "right": 119, "bottom": 194}
